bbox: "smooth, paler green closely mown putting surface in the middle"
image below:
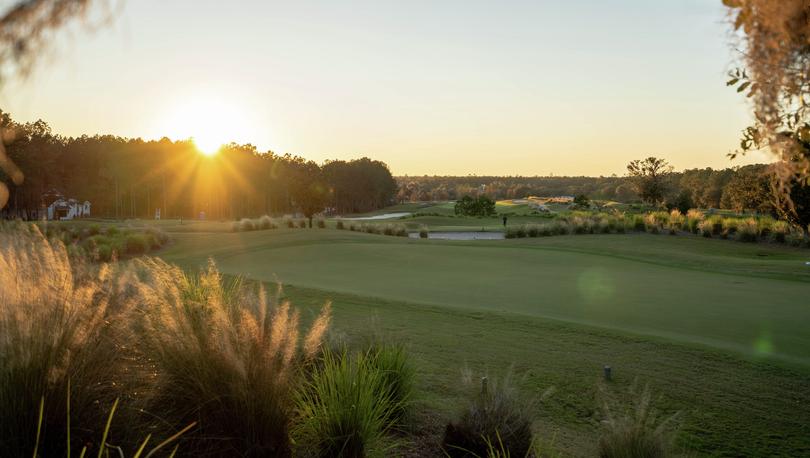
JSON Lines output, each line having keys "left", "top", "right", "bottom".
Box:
{"left": 162, "top": 230, "right": 810, "bottom": 365}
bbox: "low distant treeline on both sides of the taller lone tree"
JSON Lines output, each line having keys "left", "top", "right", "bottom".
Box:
{"left": 397, "top": 164, "right": 770, "bottom": 212}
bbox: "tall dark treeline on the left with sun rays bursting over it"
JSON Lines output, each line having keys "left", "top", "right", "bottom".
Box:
{"left": 0, "top": 112, "right": 397, "bottom": 219}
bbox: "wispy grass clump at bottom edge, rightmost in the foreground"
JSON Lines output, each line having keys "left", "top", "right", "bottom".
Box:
{"left": 598, "top": 387, "right": 678, "bottom": 458}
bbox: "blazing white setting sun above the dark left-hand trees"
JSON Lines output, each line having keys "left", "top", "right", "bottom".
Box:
{"left": 155, "top": 95, "right": 249, "bottom": 157}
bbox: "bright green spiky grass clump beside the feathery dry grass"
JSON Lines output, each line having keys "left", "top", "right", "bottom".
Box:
{"left": 293, "top": 351, "right": 393, "bottom": 457}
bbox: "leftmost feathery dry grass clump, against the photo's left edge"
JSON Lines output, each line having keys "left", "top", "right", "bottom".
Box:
{"left": 0, "top": 224, "right": 131, "bottom": 456}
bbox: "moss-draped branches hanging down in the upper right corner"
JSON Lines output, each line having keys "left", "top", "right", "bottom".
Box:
{"left": 723, "top": 0, "right": 810, "bottom": 217}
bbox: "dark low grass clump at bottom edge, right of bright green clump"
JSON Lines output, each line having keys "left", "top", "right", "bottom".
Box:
{"left": 442, "top": 372, "right": 535, "bottom": 457}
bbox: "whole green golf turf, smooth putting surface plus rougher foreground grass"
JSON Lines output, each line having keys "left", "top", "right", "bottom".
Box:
{"left": 156, "top": 217, "right": 810, "bottom": 456}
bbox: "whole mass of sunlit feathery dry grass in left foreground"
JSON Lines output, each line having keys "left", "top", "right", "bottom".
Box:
{"left": 0, "top": 224, "right": 330, "bottom": 456}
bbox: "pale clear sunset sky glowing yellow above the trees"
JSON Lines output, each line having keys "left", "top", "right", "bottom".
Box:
{"left": 0, "top": 0, "right": 770, "bottom": 176}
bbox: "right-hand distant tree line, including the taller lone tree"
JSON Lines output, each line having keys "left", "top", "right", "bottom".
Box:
{"left": 397, "top": 161, "right": 810, "bottom": 227}
